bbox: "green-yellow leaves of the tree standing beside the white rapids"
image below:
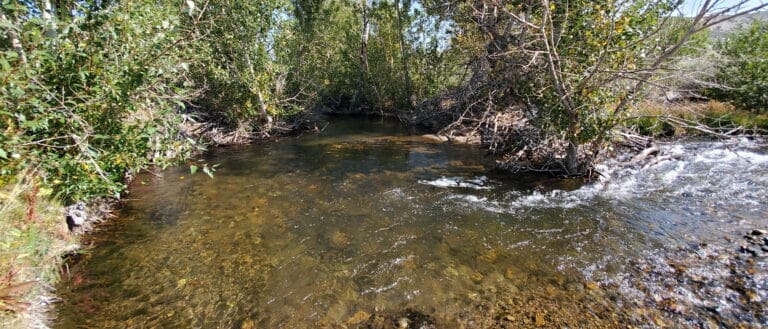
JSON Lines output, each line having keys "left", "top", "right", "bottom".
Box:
{"left": 535, "top": 1, "right": 674, "bottom": 139}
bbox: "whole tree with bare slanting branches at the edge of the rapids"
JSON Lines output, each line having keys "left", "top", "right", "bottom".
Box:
{"left": 424, "top": 0, "right": 768, "bottom": 175}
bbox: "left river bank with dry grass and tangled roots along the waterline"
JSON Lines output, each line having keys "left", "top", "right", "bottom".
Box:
{"left": 0, "top": 119, "right": 319, "bottom": 329}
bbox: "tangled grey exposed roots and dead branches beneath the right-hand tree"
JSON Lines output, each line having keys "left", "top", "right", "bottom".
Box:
{"left": 409, "top": 87, "right": 595, "bottom": 176}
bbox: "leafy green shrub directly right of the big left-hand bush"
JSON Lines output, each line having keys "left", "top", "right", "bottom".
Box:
{"left": 193, "top": 0, "right": 296, "bottom": 127}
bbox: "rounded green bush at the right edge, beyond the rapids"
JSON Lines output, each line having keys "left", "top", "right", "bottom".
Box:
{"left": 707, "top": 21, "right": 768, "bottom": 111}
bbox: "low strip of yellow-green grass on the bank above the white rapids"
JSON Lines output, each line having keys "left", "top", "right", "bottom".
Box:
{"left": 625, "top": 101, "right": 768, "bottom": 137}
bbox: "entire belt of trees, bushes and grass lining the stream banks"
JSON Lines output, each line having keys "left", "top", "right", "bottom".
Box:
{"left": 0, "top": 0, "right": 768, "bottom": 327}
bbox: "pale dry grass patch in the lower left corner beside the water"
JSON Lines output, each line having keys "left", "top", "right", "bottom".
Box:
{"left": 0, "top": 172, "right": 77, "bottom": 329}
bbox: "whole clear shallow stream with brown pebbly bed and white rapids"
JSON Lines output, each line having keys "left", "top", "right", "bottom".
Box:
{"left": 53, "top": 118, "right": 768, "bottom": 328}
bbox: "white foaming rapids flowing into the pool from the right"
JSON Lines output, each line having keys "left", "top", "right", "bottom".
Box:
{"left": 440, "top": 140, "right": 768, "bottom": 213}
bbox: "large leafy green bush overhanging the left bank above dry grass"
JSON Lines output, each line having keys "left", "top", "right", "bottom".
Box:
{"left": 0, "top": 1, "right": 200, "bottom": 201}
